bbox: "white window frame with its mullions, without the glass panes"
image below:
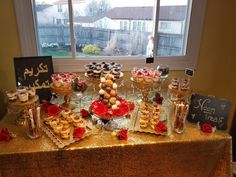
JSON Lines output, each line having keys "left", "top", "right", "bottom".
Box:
{"left": 14, "top": 0, "right": 207, "bottom": 72}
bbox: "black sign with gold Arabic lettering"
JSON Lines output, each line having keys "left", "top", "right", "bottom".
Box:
{"left": 14, "top": 56, "right": 53, "bottom": 101}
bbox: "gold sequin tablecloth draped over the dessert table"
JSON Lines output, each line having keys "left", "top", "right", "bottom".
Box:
{"left": 0, "top": 115, "right": 231, "bottom": 177}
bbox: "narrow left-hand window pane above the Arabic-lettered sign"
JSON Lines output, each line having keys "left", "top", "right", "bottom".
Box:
{"left": 35, "top": 0, "right": 71, "bottom": 56}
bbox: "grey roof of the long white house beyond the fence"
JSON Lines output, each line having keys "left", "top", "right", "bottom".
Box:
{"left": 78, "top": 6, "right": 186, "bottom": 23}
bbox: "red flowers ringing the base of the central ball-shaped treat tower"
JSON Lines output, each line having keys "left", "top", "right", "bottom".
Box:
{"left": 90, "top": 98, "right": 130, "bottom": 120}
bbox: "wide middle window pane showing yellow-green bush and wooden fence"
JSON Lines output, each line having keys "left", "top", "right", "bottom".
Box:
{"left": 73, "top": 0, "right": 154, "bottom": 57}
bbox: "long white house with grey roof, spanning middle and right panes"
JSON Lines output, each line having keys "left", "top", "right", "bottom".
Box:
{"left": 78, "top": 6, "right": 186, "bottom": 34}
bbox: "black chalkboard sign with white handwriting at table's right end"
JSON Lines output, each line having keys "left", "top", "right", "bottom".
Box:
{"left": 187, "top": 94, "right": 231, "bottom": 130}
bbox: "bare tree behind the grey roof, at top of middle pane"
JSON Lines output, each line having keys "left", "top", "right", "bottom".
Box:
{"left": 85, "top": 0, "right": 111, "bottom": 16}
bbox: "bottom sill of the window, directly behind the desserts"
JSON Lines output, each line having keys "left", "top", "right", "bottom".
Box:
{"left": 53, "top": 56, "right": 197, "bottom": 72}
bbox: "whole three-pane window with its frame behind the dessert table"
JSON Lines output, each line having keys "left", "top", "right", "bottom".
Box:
{"left": 15, "top": 0, "right": 206, "bottom": 71}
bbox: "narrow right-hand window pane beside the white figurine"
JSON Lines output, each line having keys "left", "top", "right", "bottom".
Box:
{"left": 157, "top": 0, "right": 189, "bottom": 56}
